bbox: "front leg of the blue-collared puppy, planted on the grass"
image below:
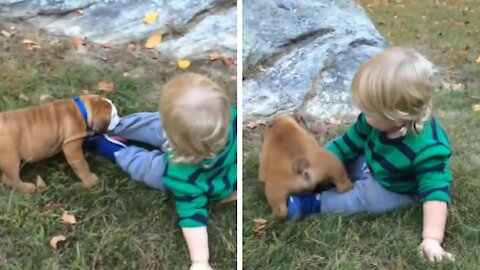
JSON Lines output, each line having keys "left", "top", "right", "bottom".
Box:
{"left": 62, "top": 140, "right": 98, "bottom": 188}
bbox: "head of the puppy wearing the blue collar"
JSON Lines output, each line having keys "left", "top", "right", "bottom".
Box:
{"left": 90, "top": 96, "right": 120, "bottom": 133}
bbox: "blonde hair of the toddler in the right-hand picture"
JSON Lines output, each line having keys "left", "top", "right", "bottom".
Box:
{"left": 352, "top": 47, "right": 434, "bottom": 133}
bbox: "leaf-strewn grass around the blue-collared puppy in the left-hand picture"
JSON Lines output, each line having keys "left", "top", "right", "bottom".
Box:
{"left": 0, "top": 24, "right": 236, "bottom": 270}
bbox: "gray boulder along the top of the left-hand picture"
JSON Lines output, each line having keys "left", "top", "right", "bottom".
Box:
{"left": 0, "top": 0, "right": 237, "bottom": 59}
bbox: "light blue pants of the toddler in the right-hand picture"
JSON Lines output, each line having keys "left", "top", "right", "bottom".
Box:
{"left": 320, "top": 156, "right": 419, "bottom": 214}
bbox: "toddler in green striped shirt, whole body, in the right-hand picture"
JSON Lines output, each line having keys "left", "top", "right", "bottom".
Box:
{"left": 288, "top": 47, "right": 453, "bottom": 261}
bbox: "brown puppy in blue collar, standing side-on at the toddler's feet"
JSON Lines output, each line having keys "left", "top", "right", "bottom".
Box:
{"left": 0, "top": 95, "right": 119, "bottom": 193}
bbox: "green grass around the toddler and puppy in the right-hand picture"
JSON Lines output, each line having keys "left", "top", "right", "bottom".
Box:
{"left": 243, "top": 0, "right": 480, "bottom": 270}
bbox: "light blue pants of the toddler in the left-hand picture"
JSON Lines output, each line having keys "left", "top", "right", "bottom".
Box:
{"left": 111, "top": 112, "right": 166, "bottom": 191}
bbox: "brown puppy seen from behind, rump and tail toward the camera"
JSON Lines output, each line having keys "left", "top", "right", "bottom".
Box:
{"left": 259, "top": 116, "right": 353, "bottom": 219}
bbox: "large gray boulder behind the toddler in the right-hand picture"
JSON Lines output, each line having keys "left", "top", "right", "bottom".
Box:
{"left": 242, "top": 0, "right": 387, "bottom": 120}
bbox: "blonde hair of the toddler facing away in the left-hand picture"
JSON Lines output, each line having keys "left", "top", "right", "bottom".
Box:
{"left": 160, "top": 73, "right": 231, "bottom": 164}
